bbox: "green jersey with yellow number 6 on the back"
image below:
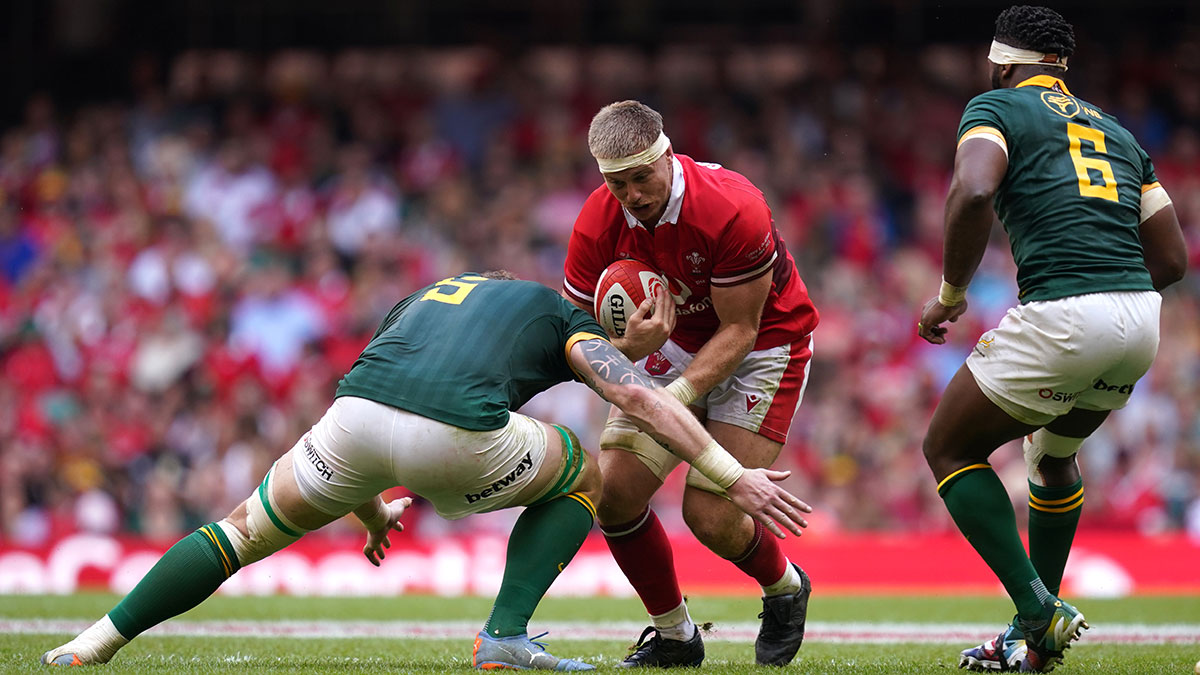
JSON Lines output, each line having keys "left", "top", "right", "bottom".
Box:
{"left": 959, "top": 74, "right": 1158, "bottom": 303}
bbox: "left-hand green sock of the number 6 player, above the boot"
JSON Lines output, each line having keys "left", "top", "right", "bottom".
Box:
{"left": 937, "top": 464, "right": 1050, "bottom": 619}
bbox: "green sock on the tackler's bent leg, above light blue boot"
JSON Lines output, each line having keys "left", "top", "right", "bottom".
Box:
{"left": 484, "top": 492, "right": 595, "bottom": 638}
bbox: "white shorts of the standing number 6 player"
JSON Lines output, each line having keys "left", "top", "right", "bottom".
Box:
{"left": 966, "top": 291, "right": 1163, "bottom": 426}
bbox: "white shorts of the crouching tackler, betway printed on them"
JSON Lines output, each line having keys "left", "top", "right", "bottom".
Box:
{"left": 289, "top": 396, "right": 557, "bottom": 520}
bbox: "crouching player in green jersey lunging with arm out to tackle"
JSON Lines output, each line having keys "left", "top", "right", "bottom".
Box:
{"left": 42, "top": 273, "right": 811, "bottom": 670}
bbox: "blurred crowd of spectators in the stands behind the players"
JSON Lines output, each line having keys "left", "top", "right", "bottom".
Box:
{"left": 0, "top": 42, "right": 1200, "bottom": 545}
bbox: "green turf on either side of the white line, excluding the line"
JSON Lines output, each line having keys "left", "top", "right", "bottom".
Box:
{"left": 7, "top": 595, "right": 1200, "bottom": 675}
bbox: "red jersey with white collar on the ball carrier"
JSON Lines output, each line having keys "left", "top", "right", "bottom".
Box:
{"left": 563, "top": 155, "right": 818, "bottom": 353}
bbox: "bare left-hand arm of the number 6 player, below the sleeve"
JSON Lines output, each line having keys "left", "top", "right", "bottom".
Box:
{"left": 942, "top": 138, "right": 1008, "bottom": 286}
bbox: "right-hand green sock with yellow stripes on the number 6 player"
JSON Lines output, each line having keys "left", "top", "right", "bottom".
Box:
{"left": 1030, "top": 479, "right": 1084, "bottom": 596}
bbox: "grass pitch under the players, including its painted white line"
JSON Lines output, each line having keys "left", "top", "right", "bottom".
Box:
{"left": 0, "top": 590, "right": 1200, "bottom": 675}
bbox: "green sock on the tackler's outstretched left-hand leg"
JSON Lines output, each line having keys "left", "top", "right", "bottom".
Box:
{"left": 108, "top": 522, "right": 241, "bottom": 640}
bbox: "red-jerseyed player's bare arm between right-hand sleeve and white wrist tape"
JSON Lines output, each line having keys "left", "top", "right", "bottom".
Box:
{"left": 683, "top": 273, "right": 772, "bottom": 394}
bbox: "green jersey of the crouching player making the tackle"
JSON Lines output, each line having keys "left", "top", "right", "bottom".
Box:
{"left": 335, "top": 274, "right": 605, "bottom": 431}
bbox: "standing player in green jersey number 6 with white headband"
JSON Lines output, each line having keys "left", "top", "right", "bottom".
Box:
{"left": 917, "top": 6, "right": 1187, "bottom": 671}
